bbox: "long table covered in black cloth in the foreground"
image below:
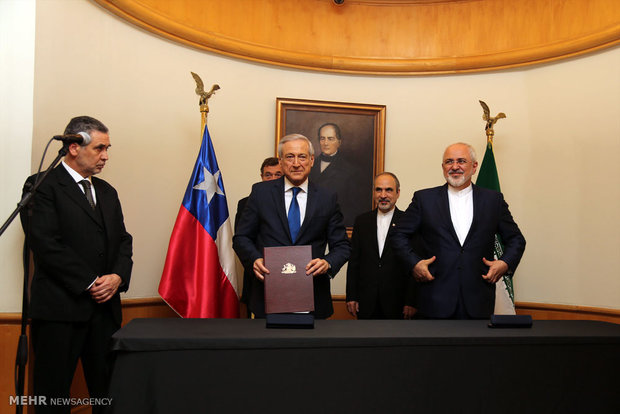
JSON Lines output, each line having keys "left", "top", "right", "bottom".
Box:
{"left": 110, "top": 319, "right": 620, "bottom": 414}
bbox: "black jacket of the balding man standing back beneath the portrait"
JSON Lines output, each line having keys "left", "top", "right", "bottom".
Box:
{"left": 347, "top": 208, "right": 415, "bottom": 319}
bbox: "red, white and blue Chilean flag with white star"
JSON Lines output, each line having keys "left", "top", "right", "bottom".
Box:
{"left": 159, "top": 126, "right": 239, "bottom": 318}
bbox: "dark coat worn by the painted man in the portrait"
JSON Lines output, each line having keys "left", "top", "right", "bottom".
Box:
{"left": 308, "top": 152, "right": 372, "bottom": 227}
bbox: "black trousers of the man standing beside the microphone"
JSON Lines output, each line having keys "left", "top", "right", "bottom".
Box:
{"left": 31, "top": 305, "right": 120, "bottom": 414}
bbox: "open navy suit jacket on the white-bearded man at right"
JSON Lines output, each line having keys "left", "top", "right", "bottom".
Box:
{"left": 391, "top": 184, "right": 525, "bottom": 318}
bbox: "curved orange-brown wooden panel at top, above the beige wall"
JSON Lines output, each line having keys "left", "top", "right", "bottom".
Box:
{"left": 95, "top": 0, "right": 620, "bottom": 75}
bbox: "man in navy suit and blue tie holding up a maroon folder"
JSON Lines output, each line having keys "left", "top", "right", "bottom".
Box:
{"left": 233, "top": 134, "right": 351, "bottom": 318}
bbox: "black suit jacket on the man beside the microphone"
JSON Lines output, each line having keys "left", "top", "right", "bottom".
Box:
{"left": 22, "top": 165, "right": 133, "bottom": 324}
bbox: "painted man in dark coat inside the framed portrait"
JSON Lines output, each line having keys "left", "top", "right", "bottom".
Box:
{"left": 310, "top": 122, "right": 369, "bottom": 226}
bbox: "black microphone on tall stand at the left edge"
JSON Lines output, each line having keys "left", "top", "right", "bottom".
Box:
{"left": 0, "top": 143, "right": 69, "bottom": 414}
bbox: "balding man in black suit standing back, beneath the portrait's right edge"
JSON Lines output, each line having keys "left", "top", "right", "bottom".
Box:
{"left": 347, "top": 172, "right": 415, "bottom": 319}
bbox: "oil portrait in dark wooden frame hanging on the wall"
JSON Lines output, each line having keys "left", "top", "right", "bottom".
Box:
{"left": 276, "top": 98, "right": 385, "bottom": 231}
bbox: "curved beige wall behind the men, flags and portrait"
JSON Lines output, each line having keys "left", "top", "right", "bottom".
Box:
{"left": 0, "top": 0, "right": 620, "bottom": 311}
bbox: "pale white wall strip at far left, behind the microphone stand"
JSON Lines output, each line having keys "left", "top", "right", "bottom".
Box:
{"left": 0, "top": 0, "right": 35, "bottom": 312}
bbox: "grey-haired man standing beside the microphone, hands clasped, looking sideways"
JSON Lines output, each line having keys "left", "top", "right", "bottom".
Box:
{"left": 26, "top": 116, "right": 133, "bottom": 413}
